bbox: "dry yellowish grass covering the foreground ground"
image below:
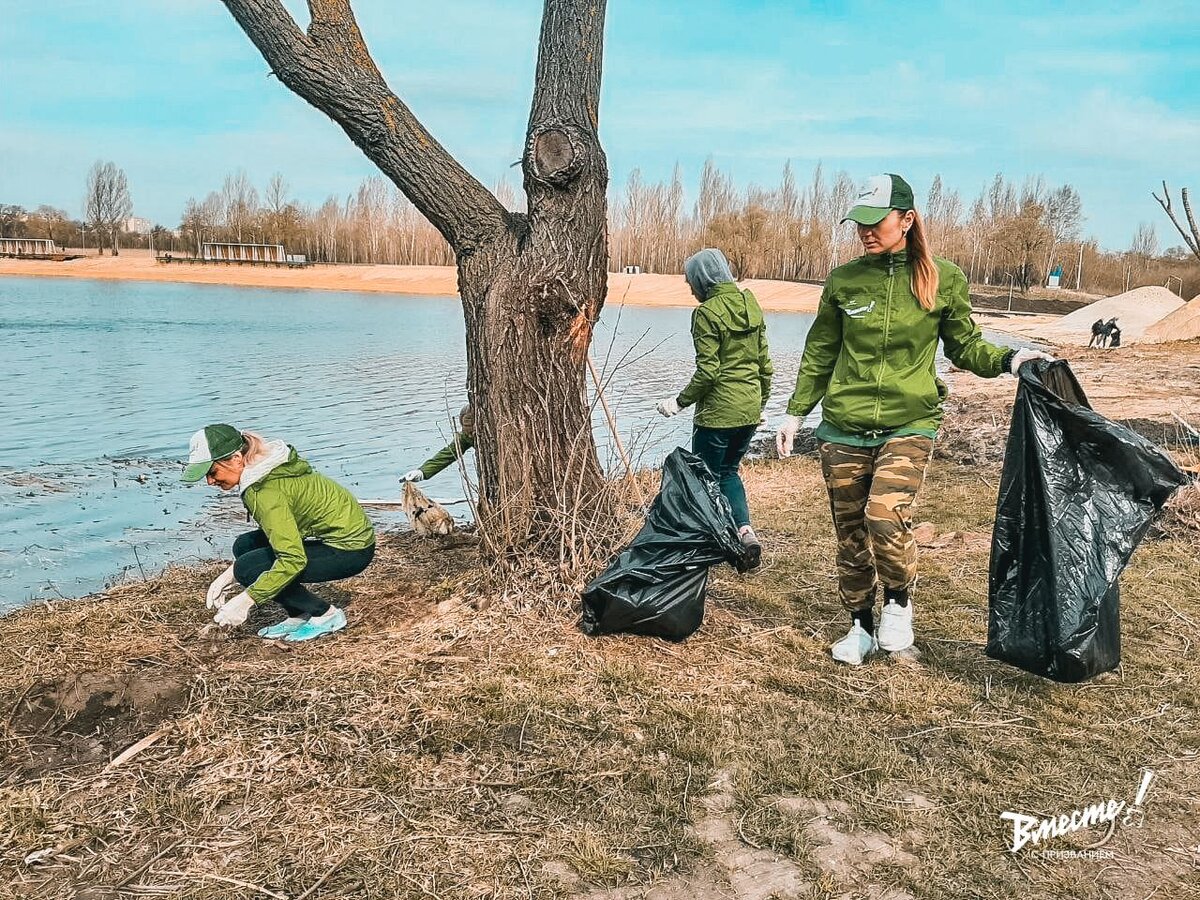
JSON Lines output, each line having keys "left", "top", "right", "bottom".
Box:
{"left": 0, "top": 458, "right": 1200, "bottom": 900}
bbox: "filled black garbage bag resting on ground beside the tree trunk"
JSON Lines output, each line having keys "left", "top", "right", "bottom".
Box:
{"left": 580, "top": 448, "right": 745, "bottom": 641}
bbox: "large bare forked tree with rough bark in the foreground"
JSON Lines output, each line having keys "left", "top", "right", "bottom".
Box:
{"left": 223, "top": 0, "right": 608, "bottom": 568}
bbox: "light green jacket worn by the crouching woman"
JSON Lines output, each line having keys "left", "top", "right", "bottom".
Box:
{"left": 241, "top": 446, "right": 374, "bottom": 604}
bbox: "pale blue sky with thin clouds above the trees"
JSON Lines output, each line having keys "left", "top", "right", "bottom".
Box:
{"left": 0, "top": 0, "right": 1200, "bottom": 248}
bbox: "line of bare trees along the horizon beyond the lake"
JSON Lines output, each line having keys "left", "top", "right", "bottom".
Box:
{"left": 0, "top": 160, "right": 1200, "bottom": 294}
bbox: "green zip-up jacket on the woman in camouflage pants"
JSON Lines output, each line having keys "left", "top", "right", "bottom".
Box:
{"left": 787, "top": 251, "right": 1012, "bottom": 434}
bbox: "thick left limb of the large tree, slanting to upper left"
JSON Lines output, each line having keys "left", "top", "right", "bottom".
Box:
{"left": 222, "top": 0, "right": 509, "bottom": 256}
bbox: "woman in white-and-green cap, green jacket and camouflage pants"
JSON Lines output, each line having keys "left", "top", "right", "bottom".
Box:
{"left": 776, "top": 174, "right": 1049, "bottom": 665}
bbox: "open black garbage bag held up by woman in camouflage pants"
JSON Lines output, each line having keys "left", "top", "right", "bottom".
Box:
{"left": 986, "top": 360, "right": 1187, "bottom": 682}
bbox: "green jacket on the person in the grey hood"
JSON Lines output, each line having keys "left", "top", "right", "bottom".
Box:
{"left": 676, "top": 282, "right": 775, "bottom": 428}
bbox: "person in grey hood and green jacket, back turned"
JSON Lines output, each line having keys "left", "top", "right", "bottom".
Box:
{"left": 658, "top": 250, "right": 774, "bottom": 568}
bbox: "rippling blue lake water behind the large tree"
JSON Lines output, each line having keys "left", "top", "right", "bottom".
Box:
{"left": 0, "top": 277, "right": 835, "bottom": 611}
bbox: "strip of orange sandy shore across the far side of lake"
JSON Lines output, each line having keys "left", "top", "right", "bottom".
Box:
{"left": 0, "top": 250, "right": 821, "bottom": 312}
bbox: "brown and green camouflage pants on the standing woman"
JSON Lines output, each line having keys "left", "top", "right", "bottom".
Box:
{"left": 821, "top": 436, "right": 934, "bottom": 610}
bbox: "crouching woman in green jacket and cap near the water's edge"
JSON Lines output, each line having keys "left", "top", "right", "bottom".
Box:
{"left": 184, "top": 425, "right": 374, "bottom": 641}
